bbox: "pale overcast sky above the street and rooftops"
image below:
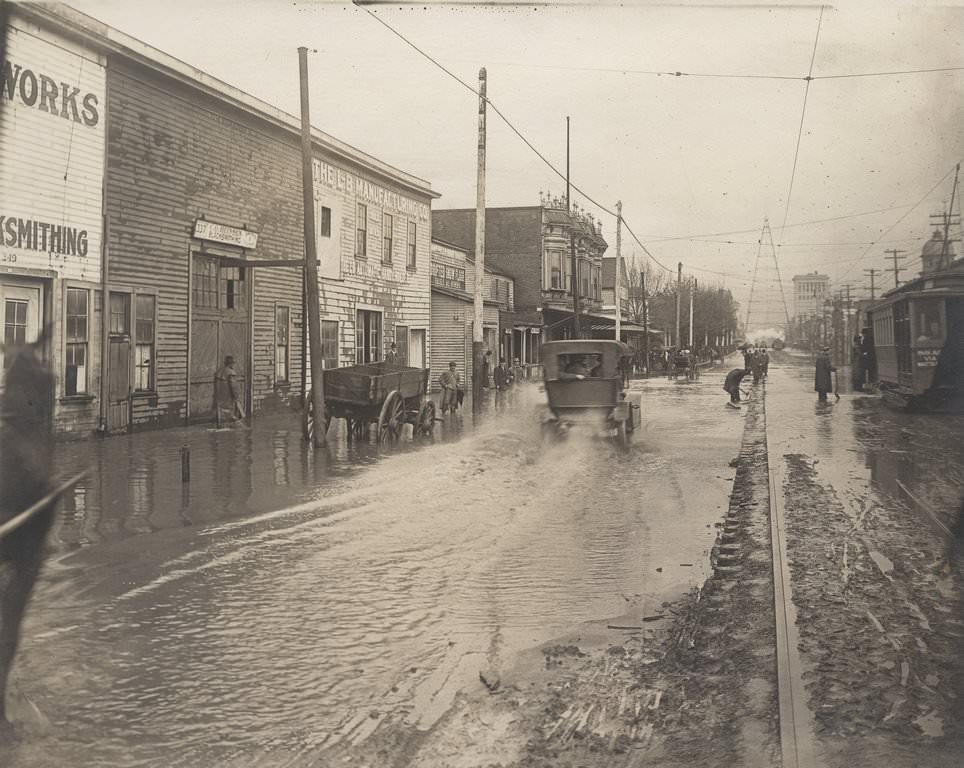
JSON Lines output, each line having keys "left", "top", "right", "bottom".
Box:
{"left": 71, "top": 0, "right": 964, "bottom": 325}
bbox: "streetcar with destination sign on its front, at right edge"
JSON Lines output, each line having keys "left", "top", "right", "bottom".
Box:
{"left": 867, "top": 260, "right": 964, "bottom": 412}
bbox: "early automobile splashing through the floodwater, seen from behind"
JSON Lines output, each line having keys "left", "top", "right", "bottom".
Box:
{"left": 542, "top": 340, "right": 641, "bottom": 445}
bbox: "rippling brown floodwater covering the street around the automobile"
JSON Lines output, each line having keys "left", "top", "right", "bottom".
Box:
{"left": 4, "top": 369, "right": 742, "bottom": 768}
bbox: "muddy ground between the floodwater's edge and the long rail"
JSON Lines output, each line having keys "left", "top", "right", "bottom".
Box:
{"left": 320, "top": 390, "right": 780, "bottom": 768}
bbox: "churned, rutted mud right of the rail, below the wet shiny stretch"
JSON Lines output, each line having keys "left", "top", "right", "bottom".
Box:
{"left": 784, "top": 454, "right": 964, "bottom": 768}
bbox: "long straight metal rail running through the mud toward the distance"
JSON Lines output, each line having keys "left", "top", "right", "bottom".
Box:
{"left": 762, "top": 384, "right": 820, "bottom": 768}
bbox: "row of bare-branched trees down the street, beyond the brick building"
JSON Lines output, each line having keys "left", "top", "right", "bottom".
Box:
{"left": 623, "top": 262, "right": 741, "bottom": 349}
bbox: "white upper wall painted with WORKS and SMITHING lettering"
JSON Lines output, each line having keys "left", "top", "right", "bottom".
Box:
{"left": 0, "top": 20, "right": 106, "bottom": 280}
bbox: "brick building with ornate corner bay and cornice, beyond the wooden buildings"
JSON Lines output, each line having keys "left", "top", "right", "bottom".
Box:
{"left": 432, "top": 197, "right": 607, "bottom": 363}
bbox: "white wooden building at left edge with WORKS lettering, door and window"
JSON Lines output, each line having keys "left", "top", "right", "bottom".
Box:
{"left": 0, "top": 7, "right": 106, "bottom": 434}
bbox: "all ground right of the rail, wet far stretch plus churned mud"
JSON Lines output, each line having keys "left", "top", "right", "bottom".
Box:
{"left": 766, "top": 355, "right": 964, "bottom": 768}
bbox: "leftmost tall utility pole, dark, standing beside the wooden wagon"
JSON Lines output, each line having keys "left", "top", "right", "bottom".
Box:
{"left": 298, "top": 46, "right": 326, "bottom": 446}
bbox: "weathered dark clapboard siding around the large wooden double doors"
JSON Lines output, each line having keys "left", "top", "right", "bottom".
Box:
{"left": 107, "top": 61, "right": 303, "bottom": 426}
